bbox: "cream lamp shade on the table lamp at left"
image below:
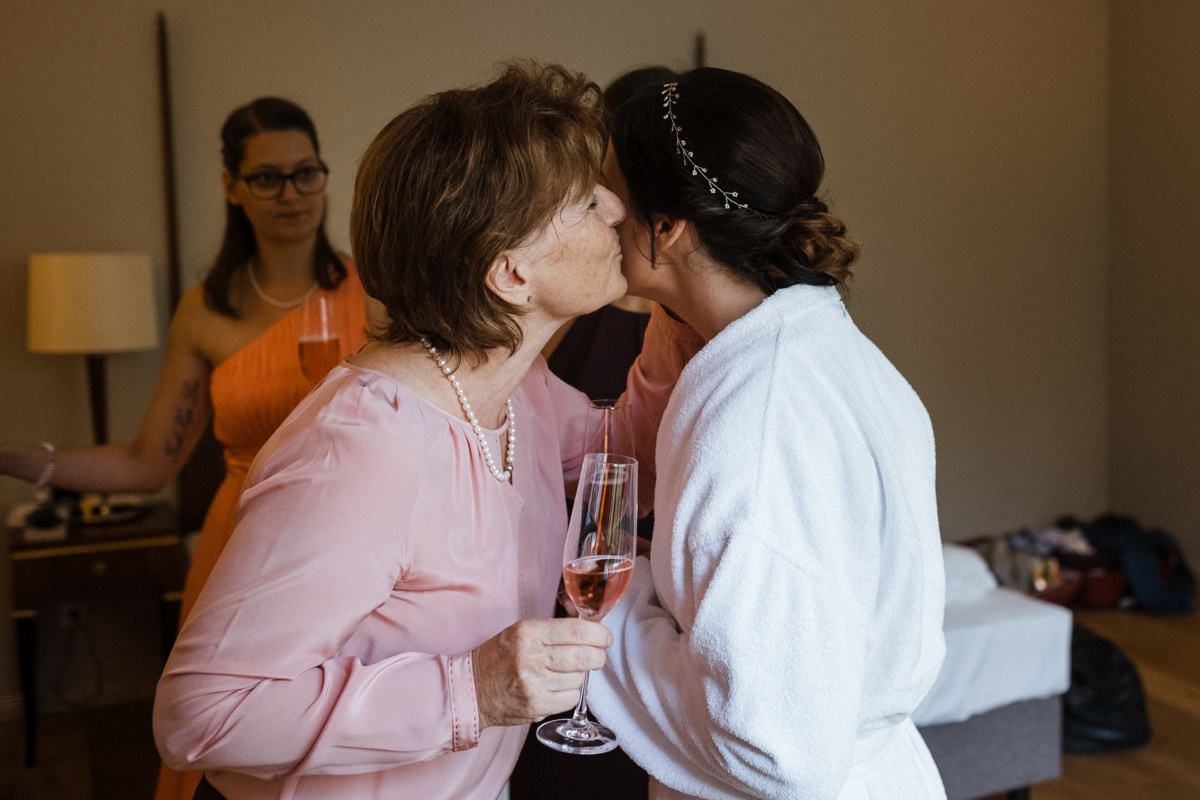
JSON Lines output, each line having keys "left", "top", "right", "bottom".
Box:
{"left": 28, "top": 253, "right": 158, "bottom": 354}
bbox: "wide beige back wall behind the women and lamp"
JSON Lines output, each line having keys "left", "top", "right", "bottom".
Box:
{"left": 0, "top": 0, "right": 1113, "bottom": 695}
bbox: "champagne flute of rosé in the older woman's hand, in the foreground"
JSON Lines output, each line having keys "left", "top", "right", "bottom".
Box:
{"left": 538, "top": 453, "right": 637, "bottom": 756}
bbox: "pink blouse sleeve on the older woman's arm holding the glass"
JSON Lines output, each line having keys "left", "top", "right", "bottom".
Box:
{"left": 154, "top": 412, "right": 479, "bottom": 778}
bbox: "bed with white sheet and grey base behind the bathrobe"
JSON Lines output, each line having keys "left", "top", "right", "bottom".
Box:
{"left": 913, "top": 543, "right": 1072, "bottom": 800}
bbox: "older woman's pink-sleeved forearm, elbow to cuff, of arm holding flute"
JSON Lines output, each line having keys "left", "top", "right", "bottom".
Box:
{"left": 154, "top": 645, "right": 479, "bottom": 778}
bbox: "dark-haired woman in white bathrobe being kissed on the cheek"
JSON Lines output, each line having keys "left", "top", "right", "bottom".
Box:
{"left": 589, "top": 68, "right": 944, "bottom": 800}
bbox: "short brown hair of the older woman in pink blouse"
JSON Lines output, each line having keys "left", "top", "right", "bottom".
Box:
{"left": 350, "top": 61, "right": 606, "bottom": 357}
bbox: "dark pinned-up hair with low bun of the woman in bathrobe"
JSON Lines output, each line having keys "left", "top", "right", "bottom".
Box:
{"left": 612, "top": 67, "right": 858, "bottom": 294}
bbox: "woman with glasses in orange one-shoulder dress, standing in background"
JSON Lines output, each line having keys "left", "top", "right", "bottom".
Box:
{"left": 0, "top": 97, "right": 367, "bottom": 800}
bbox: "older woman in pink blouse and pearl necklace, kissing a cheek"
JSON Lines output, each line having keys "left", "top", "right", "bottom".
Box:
{"left": 155, "top": 64, "right": 698, "bottom": 800}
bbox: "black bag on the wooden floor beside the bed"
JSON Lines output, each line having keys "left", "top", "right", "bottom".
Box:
{"left": 1062, "top": 625, "right": 1151, "bottom": 753}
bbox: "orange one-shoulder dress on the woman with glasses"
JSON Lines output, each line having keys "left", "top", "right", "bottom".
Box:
{"left": 155, "top": 261, "right": 367, "bottom": 800}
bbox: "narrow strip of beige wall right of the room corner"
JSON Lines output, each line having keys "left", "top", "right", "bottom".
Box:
{"left": 1109, "top": 0, "right": 1200, "bottom": 566}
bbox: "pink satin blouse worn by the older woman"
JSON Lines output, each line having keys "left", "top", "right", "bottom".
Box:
{"left": 154, "top": 312, "right": 700, "bottom": 800}
